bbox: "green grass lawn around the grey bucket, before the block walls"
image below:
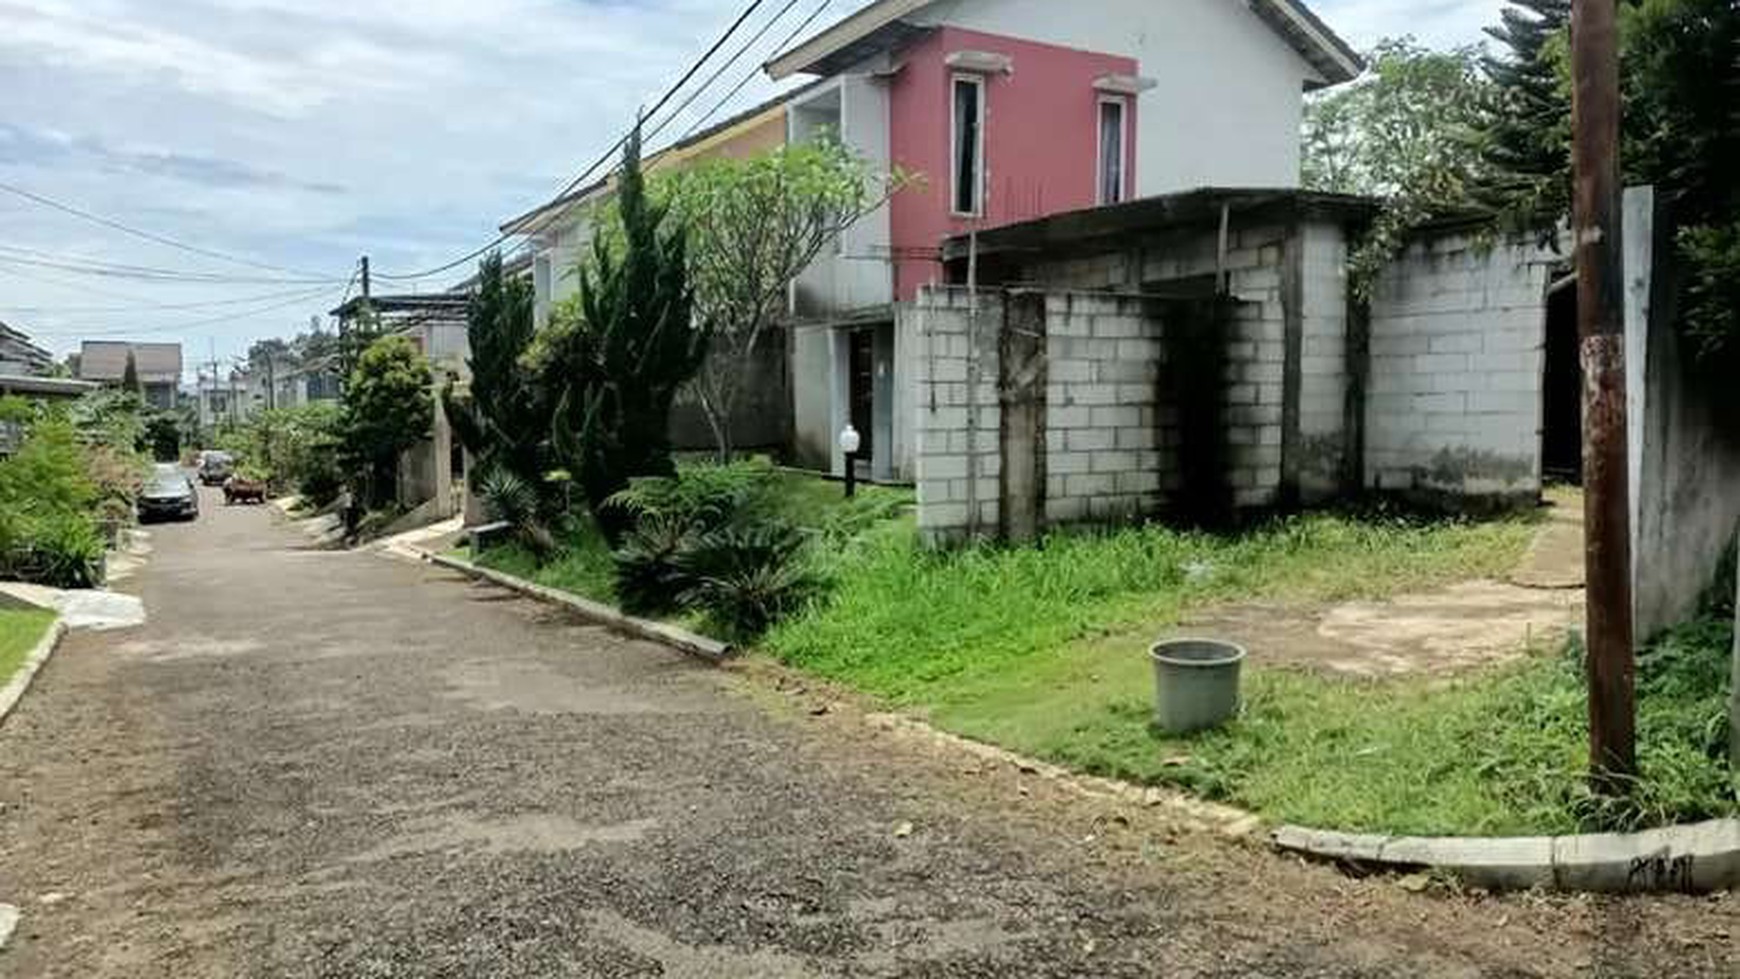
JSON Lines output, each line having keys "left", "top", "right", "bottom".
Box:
{"left": 764, "top": 515, "right": 1735, "bottom": 835}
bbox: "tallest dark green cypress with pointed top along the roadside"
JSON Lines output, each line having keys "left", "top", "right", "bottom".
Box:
{"left": 545, "top": 130, "right": 708, "bottom": 543}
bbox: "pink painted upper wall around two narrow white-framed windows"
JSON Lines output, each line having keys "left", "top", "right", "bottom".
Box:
{"left": 889, "top": 28, "right": 1138, "bottom": 301}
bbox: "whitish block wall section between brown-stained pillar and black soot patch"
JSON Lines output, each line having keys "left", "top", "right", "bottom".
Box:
{"left": 1044, "top": 292, "right": 1176, "bottom": 523}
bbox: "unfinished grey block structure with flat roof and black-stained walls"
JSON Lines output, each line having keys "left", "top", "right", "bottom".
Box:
{"left": 900, "top": 190, "right": 1561, "bottom": 537}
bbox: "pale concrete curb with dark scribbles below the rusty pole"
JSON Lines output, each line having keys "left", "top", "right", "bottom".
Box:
{"left": 1274, "top": 819, "right": 1740, "bottom": 894}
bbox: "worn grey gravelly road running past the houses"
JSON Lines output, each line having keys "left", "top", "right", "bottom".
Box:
{"left": 0, "top": 501, "right": 1737, "bottom": 979}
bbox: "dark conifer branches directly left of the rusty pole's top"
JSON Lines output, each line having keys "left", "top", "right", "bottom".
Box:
{"left": 1477, "top": 0, "right": 1571, "bottom": 240}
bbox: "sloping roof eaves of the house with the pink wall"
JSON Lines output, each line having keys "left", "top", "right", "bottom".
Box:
{"left": 767, "top": 0, "right": 1366, "bottom": 85}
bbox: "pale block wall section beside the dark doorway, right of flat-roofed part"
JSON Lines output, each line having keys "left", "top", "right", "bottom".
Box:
{"left": 1366, "top": 235, "right": 1550, "bottom": 501}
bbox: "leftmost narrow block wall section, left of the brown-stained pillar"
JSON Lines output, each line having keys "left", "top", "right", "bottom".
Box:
{"left": 896, "top": 287, "right": 1004, "bottom": 543}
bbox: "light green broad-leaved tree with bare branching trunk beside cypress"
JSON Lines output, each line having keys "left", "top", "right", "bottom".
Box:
{"left": 670, "top": 137, "right": 903, "bottom": 461}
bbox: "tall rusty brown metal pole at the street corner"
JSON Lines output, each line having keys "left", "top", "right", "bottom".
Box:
{"left": 1571, "top": 0, "right": 1637, "bottom": 793}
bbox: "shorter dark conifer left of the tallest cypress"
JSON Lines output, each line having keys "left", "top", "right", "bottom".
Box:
{"left": 442, "top": 252, "right": 550, "bottom": 490}
